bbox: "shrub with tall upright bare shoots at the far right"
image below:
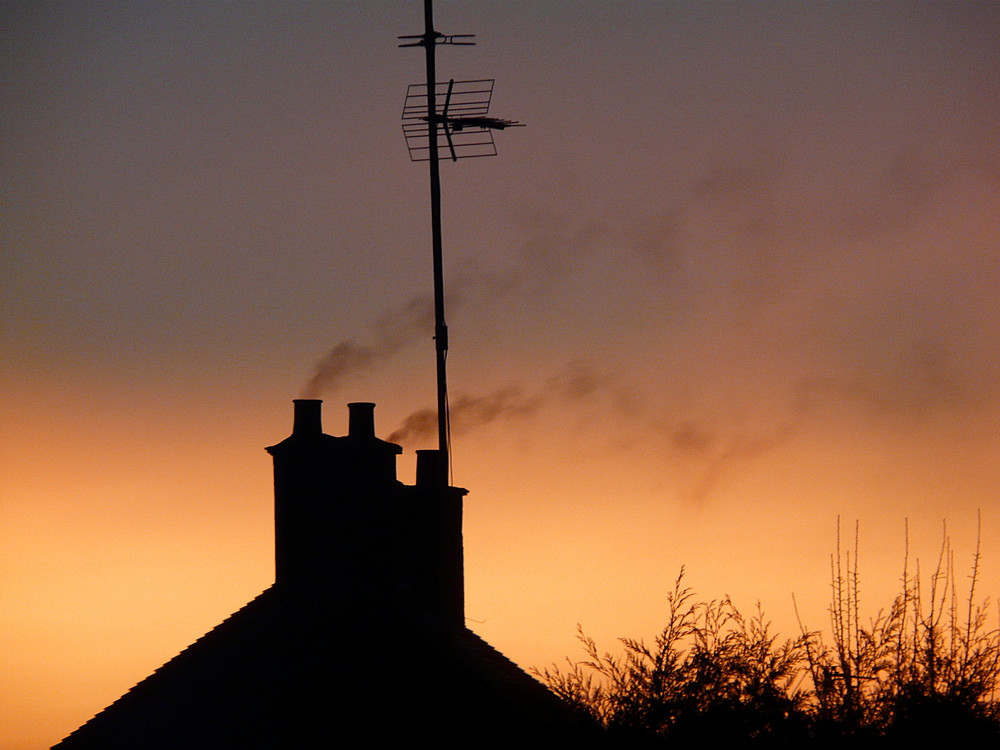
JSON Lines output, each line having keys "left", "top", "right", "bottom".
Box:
{"left": 802, "top": 528, "right": 1000, "bottom": 740}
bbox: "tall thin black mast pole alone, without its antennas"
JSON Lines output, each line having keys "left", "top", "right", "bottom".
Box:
{"left": 423, "top": 0, "right": 451, "bottom": 476}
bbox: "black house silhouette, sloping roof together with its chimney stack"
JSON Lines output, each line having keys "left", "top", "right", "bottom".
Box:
{"left": 57, "top": 399, "right": 594, "bottom": 750}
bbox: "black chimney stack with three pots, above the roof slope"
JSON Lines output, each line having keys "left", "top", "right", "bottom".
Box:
{"left": 267, "top": 399, "right": 465, "bottom": 627}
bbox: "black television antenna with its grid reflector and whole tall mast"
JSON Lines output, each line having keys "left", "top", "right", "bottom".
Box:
{"left": 399, "top": 0, "right": 523, "bottom": 482}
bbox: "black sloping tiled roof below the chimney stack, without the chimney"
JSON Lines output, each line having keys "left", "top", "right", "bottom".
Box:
{"left": 57, "top": 586, "right": 592, "bottom": 750}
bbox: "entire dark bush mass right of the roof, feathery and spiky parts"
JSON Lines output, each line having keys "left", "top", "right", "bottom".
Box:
{"left": 533, "top": 523, "right": 1000, "bottom": 747}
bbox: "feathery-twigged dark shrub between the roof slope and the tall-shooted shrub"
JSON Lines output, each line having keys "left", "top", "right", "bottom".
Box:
{"left": 535, "top": 570, "right": 806, "bottom": 747}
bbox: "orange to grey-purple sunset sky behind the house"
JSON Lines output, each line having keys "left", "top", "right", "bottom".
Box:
{"left": 0, "top": 0, "right": 1000, "bottom": 750}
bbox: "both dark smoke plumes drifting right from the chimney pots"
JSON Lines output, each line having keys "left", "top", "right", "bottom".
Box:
{"left": 306, "top": 150, "right": 976, "bottom": 504}
